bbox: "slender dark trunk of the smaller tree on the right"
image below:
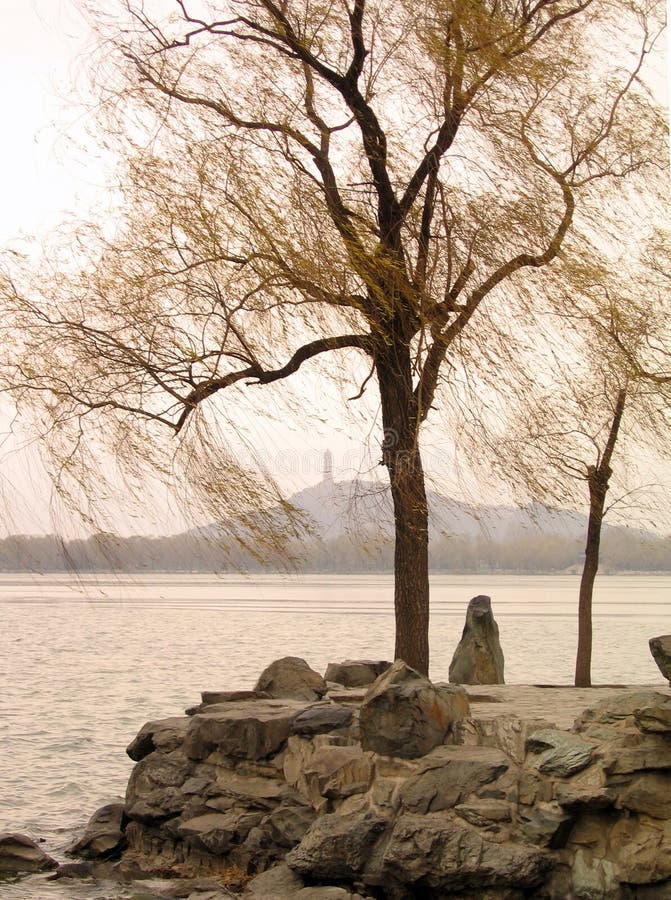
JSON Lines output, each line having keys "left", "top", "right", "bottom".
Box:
{"left": 574, "top": 389, "right": 627, "bottom": 687}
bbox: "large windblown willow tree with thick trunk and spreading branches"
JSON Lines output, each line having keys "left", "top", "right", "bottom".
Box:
{"left": 0, "top": 0, "right": 663, "bottom": 672}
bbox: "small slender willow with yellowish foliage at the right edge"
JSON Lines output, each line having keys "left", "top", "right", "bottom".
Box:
{"left": 490, "top": 230, "right": 671, "bottom": 687}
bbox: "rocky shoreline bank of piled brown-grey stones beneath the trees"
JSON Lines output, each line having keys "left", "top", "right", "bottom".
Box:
{"left": 5, "top": 658, "right": 671, "bottom": 900}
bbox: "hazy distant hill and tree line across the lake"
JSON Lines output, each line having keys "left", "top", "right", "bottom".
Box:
{"left": 0, "top": 475, "right": 671, "bottom": 573}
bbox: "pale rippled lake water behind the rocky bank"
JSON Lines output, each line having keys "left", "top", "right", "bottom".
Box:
{"left": 0, "top": 575, "right": 671, "bottom": 900}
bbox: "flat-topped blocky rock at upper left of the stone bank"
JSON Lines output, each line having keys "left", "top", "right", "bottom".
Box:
{"left": 184, "top": 700, "right": 305, "bottom": 760}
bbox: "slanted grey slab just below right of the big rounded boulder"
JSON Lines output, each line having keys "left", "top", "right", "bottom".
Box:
{"left": 399, "top": 747, "right": 510, "bottom": 814}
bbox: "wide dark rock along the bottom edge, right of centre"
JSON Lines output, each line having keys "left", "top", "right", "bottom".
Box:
{"left": 381, "top": 815, "right": 551, "bottom": 897}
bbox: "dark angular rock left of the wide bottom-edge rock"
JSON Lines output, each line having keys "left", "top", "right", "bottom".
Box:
{"left": 286, "top": 813, "right": 386, "bottom": 881}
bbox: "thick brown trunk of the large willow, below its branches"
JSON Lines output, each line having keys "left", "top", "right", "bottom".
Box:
{"left": 376, "top": 347, "right": 429, "bottom": 675}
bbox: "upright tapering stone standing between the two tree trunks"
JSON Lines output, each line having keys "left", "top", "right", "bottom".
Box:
{"left": 450, "top": 594, "right": 504, "bottom": 684}
